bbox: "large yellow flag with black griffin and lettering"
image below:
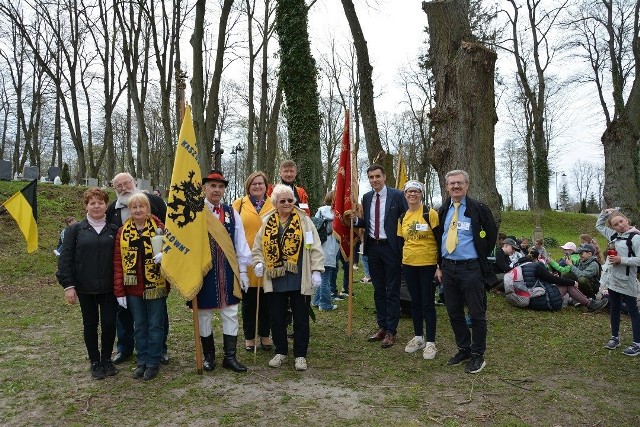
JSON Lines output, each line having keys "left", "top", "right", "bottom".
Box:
{"left": 162, "top": 106, "right": 212, "bottom": 300}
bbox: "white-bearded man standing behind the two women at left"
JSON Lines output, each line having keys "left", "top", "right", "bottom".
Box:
{"left": 107, "top": 172, "right": 169, "bottom": 364}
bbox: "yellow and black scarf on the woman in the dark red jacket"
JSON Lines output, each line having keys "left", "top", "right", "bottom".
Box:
{"left": 120, "top": 218, "right": 168, "bottom": 299}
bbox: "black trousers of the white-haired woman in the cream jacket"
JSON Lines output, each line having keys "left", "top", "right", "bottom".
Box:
{"left": 267, "top": 291, "right": 311, "bottom": 357}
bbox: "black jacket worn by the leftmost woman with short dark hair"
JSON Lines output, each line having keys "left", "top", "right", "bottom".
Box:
{"left": 56, "top": 218, "right": 118, "bottom": 294}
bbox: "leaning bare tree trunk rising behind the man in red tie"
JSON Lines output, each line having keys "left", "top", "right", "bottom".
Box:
{"left": 342, "top": 0, "right": 395, "bottom": 183}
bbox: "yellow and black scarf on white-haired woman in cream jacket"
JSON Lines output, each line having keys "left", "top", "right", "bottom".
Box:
{"left": 262, "top": 210, "right": 302, "bottom": 278}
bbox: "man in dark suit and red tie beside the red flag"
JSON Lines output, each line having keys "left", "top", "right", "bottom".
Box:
{"left": 344, "top": 164, "right": 407, "bottom": 348}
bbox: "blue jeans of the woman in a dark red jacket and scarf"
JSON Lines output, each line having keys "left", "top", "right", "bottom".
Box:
{"left": 127, "top": 295, "right": 167, "bottom": 367}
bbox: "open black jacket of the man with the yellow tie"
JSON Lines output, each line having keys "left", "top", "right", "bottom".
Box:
{"left": 438, "top": 196, "right": 498, "bottom": 286}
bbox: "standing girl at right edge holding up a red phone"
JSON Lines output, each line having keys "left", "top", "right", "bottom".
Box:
{"left": 596, "top": 209, "right": 640, "bottom": 356}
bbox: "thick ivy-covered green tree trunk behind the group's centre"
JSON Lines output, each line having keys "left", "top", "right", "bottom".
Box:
{"left": 276, "top": 0, "right": 324, "bottom": 210}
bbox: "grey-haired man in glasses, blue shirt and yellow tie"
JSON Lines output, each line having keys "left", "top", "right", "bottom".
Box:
{"left": 436, "top": 170, "right": 498, "bottom": 374}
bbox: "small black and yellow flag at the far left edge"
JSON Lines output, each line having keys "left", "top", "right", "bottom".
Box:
{"left": 2, "top": 179, "right": 38, "bottom": 253}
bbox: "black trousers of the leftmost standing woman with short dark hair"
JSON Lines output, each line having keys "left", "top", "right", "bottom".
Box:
{"left": 78, "top": 292, "right": 118, "bottom": 363}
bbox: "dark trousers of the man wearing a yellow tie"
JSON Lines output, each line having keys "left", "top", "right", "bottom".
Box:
{"left": 441, "top": 259, "right": 487, "bottom": 355}
